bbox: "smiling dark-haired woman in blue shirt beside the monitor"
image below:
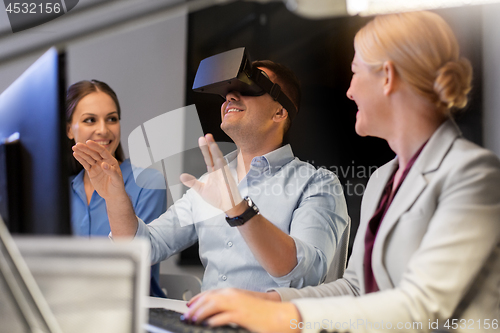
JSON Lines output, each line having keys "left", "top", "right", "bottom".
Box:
{"left": 66, "top": 80, "right": 166, "bottom": 297}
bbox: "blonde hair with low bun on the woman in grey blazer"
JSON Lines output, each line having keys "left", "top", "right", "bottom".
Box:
{"left": 354, "top": 11, "right": 472, "bottom": 113}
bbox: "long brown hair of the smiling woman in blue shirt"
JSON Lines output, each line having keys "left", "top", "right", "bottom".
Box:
{"left": 66, "top": 80, "right": 125, "bottom": 175}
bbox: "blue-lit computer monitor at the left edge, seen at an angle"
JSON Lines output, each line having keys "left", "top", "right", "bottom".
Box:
{"left": 0, "top": 48, "right": 71, "bottom": 235}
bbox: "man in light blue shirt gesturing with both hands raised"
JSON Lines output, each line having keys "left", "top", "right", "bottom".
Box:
{"left": 73, "top": 50, "right": 349, "bottom": 291}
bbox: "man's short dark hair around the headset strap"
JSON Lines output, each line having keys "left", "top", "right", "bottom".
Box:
{"left": 252, "top": 60, "right": 301, "bottom": 133}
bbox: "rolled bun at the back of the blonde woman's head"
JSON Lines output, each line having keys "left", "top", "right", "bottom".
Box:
{"left": 434, "top": 58, "right": 472, "bottom": 109}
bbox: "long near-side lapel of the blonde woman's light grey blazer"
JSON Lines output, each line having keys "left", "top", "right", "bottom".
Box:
{"left": 372, "top": 119, "right": 460, "bottom": 289}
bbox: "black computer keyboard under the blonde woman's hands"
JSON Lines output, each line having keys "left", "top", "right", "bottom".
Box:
{"left": 148, "top": 308, "right": 250, "bottom": 333}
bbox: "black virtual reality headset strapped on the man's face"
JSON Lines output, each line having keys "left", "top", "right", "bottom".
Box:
{"left": 193, "top": 47, "right": 297, "bottom": 120}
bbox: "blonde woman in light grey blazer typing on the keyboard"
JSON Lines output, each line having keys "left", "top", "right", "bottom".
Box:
{"left": 185, "top": 12, "right": 500, "bottom": 332}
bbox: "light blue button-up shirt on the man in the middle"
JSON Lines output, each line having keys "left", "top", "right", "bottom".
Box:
{"left": 136, "top": 145, "right": 349, "bottom": 291}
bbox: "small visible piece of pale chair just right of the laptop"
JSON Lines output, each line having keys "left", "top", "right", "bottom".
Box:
{"left": 159, "top": 274, "right": 201, "bottom": 301}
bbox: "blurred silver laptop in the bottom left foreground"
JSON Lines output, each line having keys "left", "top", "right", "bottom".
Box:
{"left": 0, "top": 237, "right": 150, "bottom": 333}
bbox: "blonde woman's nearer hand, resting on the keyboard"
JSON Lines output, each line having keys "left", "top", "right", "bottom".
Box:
{"left": 184, "top": 288, "right": 300, "bottom": 332}
